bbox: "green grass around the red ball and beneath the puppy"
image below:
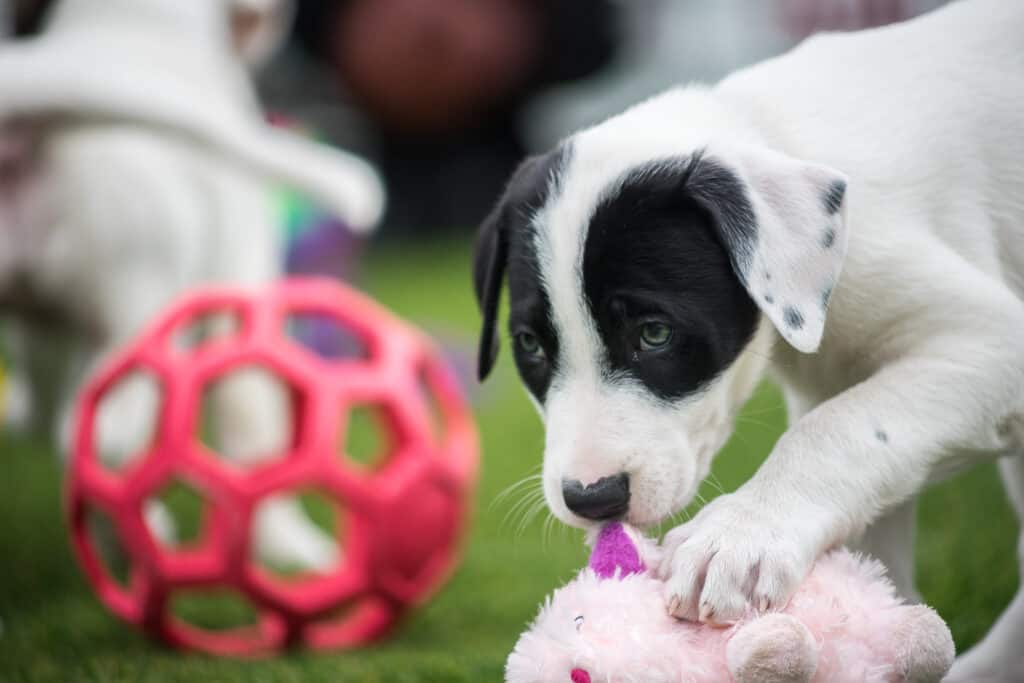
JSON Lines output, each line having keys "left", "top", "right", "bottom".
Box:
{"left": 0, "top": 245, "right": 1017, "bottom": 683}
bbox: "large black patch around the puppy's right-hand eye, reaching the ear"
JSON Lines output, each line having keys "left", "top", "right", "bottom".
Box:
{"left": 583, "top": 157, "right": 758, "bottom": 400}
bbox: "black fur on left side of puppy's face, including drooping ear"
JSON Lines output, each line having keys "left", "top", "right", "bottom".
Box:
{"left": 473, "top": 145, "right": 569, "bottom": 401}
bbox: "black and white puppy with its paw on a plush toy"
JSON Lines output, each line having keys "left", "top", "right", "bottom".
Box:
{"left": 474, "top": 0, "right": 1024, "bottom": 680}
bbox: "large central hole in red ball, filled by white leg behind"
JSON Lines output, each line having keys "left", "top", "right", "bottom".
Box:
{"left": 197, "top": 365, "right": 301, "bottom": 469}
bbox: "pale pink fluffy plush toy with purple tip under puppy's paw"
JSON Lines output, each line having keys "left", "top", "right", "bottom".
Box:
{"left": 505, "top": 522, "right": 954, "bottom": 683}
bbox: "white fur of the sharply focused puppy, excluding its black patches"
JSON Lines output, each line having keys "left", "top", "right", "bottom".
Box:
{"left": 536, "top": 0, "right": 1024, "bottom": 680}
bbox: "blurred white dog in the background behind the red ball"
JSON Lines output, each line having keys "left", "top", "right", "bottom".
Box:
{"left": 0, "top": 0, "right": 384, "bottom": 566}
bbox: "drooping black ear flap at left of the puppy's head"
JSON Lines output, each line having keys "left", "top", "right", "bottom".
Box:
{"left": 473, "top": 198, "right": 509, "bottom": 381}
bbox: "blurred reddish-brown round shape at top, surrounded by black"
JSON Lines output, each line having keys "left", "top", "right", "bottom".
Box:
{"left": 325, "top": 0, "right": 541, "bottom": 135}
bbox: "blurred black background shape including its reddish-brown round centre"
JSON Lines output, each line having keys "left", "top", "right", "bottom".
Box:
{"left": 296, "top": 0, "right": 620, "bottom": 236}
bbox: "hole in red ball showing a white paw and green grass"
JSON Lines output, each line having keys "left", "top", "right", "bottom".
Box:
{"left": 250, "top": 489, "right": 345, "bottom": 580}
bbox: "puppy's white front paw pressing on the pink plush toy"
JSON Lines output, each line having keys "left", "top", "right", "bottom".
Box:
{"left": 659, "top": 494, "right": 817, "bottom": 625}
